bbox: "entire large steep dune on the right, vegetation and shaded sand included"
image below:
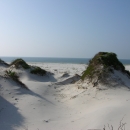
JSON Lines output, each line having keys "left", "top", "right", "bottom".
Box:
{"left": 81, "top": 52, "right": 130, "bottom": 87}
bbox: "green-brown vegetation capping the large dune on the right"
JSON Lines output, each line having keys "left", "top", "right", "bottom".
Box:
{"left": 81, "top": 52, "right": 130, "bottom": 85}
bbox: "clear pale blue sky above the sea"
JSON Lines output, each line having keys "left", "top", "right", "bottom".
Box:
{"left": 0, "top": 0, "right": 130, "bottom": 59}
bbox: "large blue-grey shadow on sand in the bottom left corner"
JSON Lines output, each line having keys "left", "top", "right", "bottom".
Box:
{"left": 0, "top": 96, "right": 24, "bottom": 130}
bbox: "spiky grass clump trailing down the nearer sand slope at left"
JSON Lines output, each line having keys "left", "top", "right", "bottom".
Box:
{"left": 5, "top": 70, "right": 28, "bottom": 89}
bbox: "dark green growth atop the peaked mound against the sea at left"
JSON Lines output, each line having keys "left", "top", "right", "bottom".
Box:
{"left": 10, "top": 58, "right": 30, "bottom": 69}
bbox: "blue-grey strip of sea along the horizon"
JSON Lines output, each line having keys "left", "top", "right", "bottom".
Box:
{"left": 0, "top": 57, "right": 130, "bottom": 65}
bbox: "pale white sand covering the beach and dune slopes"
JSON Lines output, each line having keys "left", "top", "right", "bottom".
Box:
{"left": 0, "top": 63, "right": 130, "bottom": 130}
